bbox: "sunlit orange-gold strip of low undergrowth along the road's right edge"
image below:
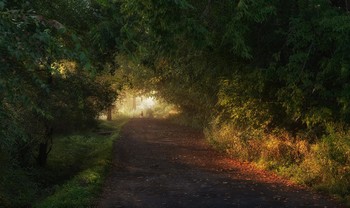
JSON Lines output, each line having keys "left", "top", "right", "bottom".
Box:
{"left": 205, "top": 120, "right": 350, "bottom": 206}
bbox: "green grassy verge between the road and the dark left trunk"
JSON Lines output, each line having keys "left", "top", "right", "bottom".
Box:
{"left": 34, "top": 119, "right": 127, "bottom": 208}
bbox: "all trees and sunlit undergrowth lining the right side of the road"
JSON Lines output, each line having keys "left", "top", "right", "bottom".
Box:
{"left": 109, "top": 0, "right": 350, "bottom": 202}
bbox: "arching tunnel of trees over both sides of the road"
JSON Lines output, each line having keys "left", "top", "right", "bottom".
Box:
{"left": 0, "top": 0, "right": 350, "bottom": 206}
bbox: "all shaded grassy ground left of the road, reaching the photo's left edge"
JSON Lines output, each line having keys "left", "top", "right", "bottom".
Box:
{"left": 0, "top": 118, "right": 128, "bottom": 208}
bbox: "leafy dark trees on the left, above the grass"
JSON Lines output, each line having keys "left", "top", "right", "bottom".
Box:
{"left": 0, "top": 1, "right": 114, "bottom": 165}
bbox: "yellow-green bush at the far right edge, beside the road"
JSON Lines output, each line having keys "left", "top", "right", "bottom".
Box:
{"left": 300, "top": 132, "right": 350, "bottom": 197}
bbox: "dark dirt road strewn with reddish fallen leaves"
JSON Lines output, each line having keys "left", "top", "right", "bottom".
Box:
{"left": 98, "top": 119, "right": 342, "bottom": 208}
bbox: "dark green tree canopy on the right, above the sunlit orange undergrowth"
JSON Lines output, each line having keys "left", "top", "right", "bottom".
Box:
{"left": 115, "top": 0, "right": 350, "bottom": 135}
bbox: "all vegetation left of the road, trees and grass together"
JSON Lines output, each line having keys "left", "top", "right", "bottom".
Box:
{"left": 0, "top": 0, "right": 124, "bottom": 208}
